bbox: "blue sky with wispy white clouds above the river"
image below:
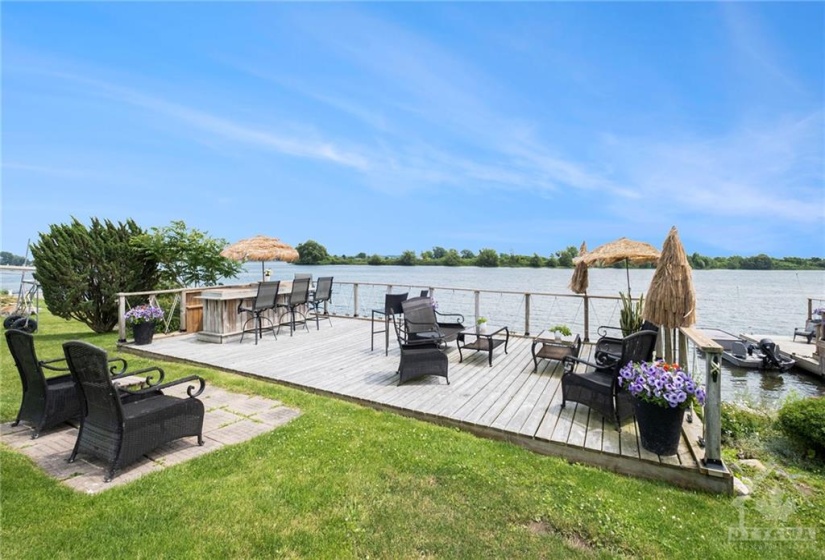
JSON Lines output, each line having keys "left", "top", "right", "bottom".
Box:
{"left": 0, "top": 2, "right": 825, "bottom": 257}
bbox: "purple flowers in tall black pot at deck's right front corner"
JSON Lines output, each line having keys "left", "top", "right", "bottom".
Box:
{"left": 619, "top": 360, "right": 705, "bottom": 455}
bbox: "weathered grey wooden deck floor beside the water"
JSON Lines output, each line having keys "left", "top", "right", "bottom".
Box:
{"left": 121, "top": 317, "right": 732, "bottom": 493}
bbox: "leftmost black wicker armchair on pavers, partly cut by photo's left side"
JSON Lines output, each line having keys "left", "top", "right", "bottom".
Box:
{"left": 6, "top": 329, "right": 140, "bottom": 439}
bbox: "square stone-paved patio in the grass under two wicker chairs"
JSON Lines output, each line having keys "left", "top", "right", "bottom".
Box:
{"left": 0, "top": 385, "right": 300, "bottom": 494}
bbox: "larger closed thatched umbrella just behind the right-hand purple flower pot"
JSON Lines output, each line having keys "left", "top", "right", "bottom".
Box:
{"left": 644, "top": 226, "right": 696, "bottom": 361}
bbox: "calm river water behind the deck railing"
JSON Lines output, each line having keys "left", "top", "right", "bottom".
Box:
{"left": 0, "top": 263, "right": 825, "bottom": 407}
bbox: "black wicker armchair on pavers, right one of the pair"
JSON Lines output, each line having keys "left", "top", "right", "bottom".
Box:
{"left": 63, "top": 341, "right": 206, "bottom": 482}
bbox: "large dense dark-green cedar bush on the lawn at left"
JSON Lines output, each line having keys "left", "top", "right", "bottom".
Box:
{"left": 32, "top": 218, "right": 159, "bottom": 333}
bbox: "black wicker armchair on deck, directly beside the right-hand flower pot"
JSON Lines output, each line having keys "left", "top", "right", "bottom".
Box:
{"left": 561, "top": 330, "right": 656, "bottom": 431}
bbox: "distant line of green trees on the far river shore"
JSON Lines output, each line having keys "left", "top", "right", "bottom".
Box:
{"left": 296, "top": 239, "right": 825, "bottom": 270}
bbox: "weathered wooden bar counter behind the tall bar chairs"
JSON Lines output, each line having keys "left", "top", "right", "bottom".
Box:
{"left": 197, "top": 281, "right": 292, "bottom": 344}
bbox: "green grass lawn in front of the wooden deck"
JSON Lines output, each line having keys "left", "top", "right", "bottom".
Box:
{"left": 0, "top": 313, "right": 825, "bottom": 559}
